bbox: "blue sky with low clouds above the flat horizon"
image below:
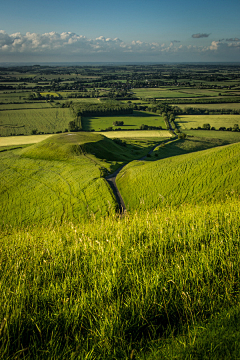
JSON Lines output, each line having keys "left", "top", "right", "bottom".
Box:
{"left": 0, "top": 0, "right": 240, "bottom": 64}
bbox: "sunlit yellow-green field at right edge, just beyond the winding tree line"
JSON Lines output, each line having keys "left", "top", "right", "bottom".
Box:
{"left": 176, "top": 115, "right": 240, "bottom": 131}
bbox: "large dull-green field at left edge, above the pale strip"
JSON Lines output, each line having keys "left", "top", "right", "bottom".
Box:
{"left": 0, "top": 108, "right": 73, "bottom": 136}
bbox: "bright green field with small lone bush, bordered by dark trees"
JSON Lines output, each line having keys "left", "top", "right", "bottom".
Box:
{"left": 82, "top": 111, "right": 166, "bottom": 131}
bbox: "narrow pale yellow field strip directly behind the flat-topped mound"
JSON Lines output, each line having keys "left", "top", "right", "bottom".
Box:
{"left": 99, "top": 130, "right": 172, "bottom": 139}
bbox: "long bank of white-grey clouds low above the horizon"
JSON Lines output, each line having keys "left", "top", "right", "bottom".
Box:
{"left": 0, "top": 30, "right": 240, "bottom": 61}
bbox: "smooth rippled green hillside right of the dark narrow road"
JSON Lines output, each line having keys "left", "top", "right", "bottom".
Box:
{"left": 117, "top": 143, "right": 240, "bottom": 210}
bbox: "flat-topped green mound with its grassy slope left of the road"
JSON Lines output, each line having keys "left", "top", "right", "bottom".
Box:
{"left": 0, "top": 132, "right": 167, "bottom": 226}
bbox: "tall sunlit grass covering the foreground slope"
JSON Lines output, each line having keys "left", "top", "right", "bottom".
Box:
{"left": 0, "top": 199, "right": 240, "bottom": 360}
